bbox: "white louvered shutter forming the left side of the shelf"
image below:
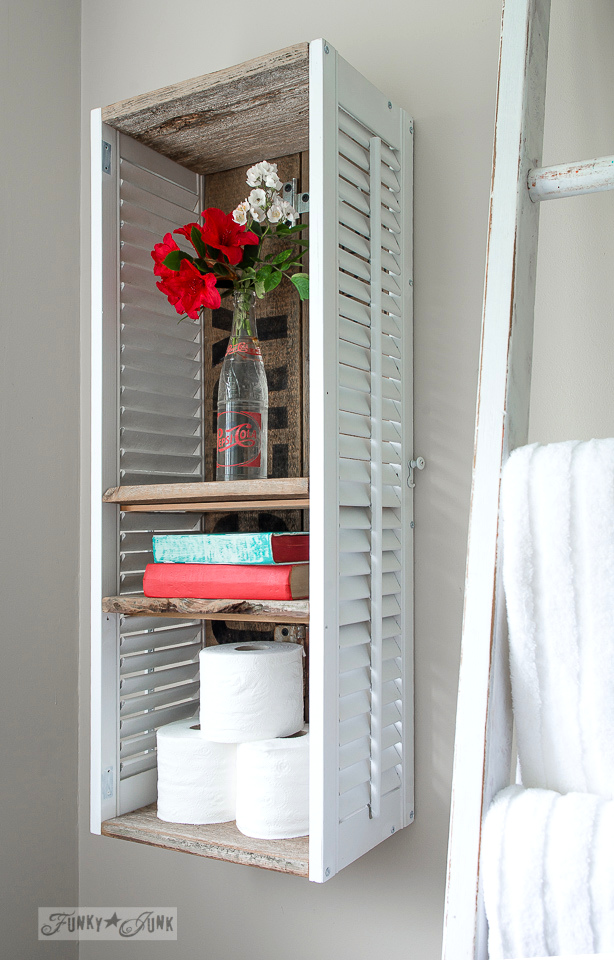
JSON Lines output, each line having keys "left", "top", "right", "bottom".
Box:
{"left": 92, "top": 118, "right": 204, "bottom": 831}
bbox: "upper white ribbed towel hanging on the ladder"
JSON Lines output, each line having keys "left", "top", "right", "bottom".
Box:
{"left": 501, "top": 439, "right": 614, "bottom": 798}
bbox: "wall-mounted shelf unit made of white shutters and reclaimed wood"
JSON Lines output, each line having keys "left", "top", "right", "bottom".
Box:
{"left": 91, "top": 40, "right": 413, "bottom": 882}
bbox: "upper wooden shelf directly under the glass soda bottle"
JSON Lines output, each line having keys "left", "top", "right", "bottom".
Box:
{"left": 102, "top": 477, "right": 309, "bottom": 510}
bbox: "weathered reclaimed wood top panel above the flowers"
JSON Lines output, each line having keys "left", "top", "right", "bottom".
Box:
{"left": 102, "top": 43, "right": 309, "bottom": 173}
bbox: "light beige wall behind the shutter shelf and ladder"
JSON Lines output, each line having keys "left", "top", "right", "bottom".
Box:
{"left": 80, "top": 0, "right": 614, "bottom": 960}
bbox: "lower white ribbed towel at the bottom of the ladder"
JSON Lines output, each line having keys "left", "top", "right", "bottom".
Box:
{"left": 481, "top": 786, "right": 614, "bottom": 960}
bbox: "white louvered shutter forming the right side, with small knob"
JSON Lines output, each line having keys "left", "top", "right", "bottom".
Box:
{"left": 310, "top": 41, "right": 413, "bottom": 881}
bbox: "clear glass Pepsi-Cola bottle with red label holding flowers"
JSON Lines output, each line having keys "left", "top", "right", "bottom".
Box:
{"left": 216, "top": 290, "right": 269, "bottom": 480}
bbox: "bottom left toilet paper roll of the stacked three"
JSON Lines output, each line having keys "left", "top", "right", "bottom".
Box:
{"left": 157, "top": 717, "right": 237, "bottom": 823}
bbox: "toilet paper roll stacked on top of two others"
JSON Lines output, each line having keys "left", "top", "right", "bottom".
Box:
{"left": 200, "top": 641, "right": 304, "bottom": 743}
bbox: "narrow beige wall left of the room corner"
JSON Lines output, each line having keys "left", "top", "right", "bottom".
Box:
{"left": 0, "top": 0, "right": 80, "bottom": 960}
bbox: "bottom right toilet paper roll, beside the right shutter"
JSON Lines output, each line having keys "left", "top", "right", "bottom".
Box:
{"left": 237, "top": 727, "right": 309, "bottom": 840}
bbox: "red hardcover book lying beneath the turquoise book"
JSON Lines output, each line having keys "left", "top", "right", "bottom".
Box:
{"left": 143, "top": 563, "right": 309, "bottom": 600}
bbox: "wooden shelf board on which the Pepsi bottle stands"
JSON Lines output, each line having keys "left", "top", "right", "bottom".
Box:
{"left": 102, "top": 477, "right": 309, "bottom": 513}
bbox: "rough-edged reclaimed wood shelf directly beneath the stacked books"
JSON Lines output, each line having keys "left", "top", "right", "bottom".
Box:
{"left": 102, "top": 594, "right": 309, "bottom": 623}
